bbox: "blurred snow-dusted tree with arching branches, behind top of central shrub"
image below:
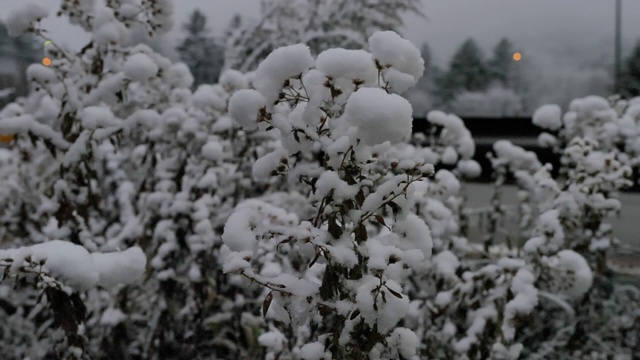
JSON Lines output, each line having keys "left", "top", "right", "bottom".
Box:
{"left": 224, "top": 0, "right": 422, "bottom": 71}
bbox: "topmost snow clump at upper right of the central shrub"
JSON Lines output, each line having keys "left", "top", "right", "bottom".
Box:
{"left": 369, "top": 31, "right": 424, "bottom": 93}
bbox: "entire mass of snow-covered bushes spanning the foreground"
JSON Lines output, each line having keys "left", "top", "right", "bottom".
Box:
{"left": 0, "top": 0, "right": 640, "bottom": 360}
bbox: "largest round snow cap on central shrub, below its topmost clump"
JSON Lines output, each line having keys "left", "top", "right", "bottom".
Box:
{"left": 344, "top": 88, "right": 413, "bottom": 145}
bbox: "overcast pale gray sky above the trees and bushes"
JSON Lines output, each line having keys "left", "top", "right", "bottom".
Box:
{"left": 0, "top": 0, "right": 640, "bottom": 64}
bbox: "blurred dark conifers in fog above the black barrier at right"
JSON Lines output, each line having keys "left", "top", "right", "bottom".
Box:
{"left": 405, "top": 38, "right": 640, "bottom": 117}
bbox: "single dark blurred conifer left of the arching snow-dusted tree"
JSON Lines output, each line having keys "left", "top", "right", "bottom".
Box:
{"left": 176, "top": 9, "right": 225, "bottom": 88}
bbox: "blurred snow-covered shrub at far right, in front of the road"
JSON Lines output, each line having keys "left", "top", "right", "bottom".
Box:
{"left": 482, "top": 136, "right": 637, "bottom": 359}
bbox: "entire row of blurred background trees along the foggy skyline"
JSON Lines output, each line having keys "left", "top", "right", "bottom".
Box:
{"left": 0, "top": 7, "right": 640, "bottom": 117}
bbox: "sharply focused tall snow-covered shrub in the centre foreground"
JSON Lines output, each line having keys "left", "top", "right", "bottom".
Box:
{"left": 222, "top": 32, "right": 433, "bottom": 359}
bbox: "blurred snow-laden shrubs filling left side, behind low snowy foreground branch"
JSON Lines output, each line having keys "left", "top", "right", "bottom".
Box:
{"left": 0, "top": 1, "right": 277, "bottom": 358}
